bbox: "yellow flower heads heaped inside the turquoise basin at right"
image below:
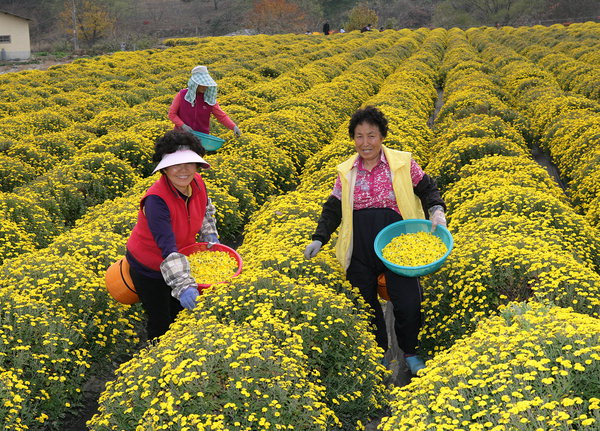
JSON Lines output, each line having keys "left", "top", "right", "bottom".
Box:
{"left": 382, "top": 232, "right": 448, "bottom": 266}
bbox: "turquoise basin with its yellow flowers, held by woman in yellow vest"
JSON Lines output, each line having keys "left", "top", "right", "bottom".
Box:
{"left": 374, "top": 220, "right": 454, "bottom": 277}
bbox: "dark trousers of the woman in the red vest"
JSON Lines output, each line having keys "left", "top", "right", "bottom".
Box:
{"left": 130, "top": 268, "right": 183, "bottom": 340}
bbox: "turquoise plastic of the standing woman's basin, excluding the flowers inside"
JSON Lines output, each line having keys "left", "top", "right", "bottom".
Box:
{"left": 373, "top": 220, "right": 454, "bottom": 277}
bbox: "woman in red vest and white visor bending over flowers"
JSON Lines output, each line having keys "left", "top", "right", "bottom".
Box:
{"left": 126, "top": 130, "right": 219, "bottom": 339}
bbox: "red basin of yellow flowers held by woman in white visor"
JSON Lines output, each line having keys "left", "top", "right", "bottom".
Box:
{"left": 179, "top": 242, "right": 243, "bottom": 289}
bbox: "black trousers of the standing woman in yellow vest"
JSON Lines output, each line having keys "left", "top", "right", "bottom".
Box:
{"left": 346, "top": 208, "right": 422, "bottom": 354}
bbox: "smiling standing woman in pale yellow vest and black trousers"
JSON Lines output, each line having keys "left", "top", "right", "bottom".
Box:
{"left": 304, "top": 106, "right": 446, "bottom": 374}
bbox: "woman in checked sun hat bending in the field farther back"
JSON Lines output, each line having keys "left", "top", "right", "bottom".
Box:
{"left": 169, "top": 66, "right": 242, "bottom": 136}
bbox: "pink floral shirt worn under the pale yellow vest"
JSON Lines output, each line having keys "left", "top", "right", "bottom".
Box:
{"left": 331, "top": 151, "right": 425, "bottom": 214}
